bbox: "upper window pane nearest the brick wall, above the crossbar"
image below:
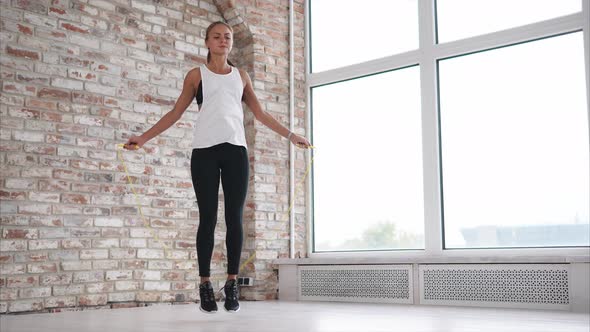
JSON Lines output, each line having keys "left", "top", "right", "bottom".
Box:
{"left": 310, "top": 0, "right": 419, "bottom": 73}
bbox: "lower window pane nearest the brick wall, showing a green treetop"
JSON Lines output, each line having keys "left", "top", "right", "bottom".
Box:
{"left": 312, "top": 67, "right": 424, "bottom": 251}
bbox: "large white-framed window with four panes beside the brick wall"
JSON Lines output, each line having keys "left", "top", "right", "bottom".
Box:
{"left": 307, "top": 0, "right": 590, "bottom": 255}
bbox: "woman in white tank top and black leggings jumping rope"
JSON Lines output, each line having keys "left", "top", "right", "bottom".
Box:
{"left": 124, "top": 22, "right": 310, "bottom": 313}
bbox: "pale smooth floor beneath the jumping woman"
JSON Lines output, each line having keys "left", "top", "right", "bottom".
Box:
{"left": 0, "top": 301, "right": 590, "bottom": 332}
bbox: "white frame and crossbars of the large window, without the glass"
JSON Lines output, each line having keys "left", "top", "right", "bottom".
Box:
{"left": 305, "top": 0, "right": 590, "bottom": 260}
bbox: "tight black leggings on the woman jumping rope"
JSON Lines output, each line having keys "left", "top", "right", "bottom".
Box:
{"left": 191, "top": 143, "right": 249, "bottom": 277}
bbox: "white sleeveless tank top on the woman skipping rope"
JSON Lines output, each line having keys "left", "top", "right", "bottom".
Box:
{"left": 193, "top": 64, "right": 247, "bottom": 149}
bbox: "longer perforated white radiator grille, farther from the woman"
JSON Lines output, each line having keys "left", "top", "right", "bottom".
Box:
{"left": 420, "top": 264, "right": 570, "bottom": 310}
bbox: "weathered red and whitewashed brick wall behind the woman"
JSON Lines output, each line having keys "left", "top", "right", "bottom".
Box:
{"left": 0, "top": 0, "right": 305, "bottom": 313}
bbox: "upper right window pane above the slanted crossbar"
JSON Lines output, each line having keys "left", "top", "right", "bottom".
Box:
{"left": 436, "top": 0, "right": 582, "bottom": 43}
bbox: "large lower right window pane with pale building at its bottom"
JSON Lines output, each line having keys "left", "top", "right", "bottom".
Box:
{"left": 439, "top": 32, "right": 590, "bottom": 248}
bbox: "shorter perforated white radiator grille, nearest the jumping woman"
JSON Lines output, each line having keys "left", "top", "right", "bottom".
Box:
{"left": 299, "top": 265, "right": 413, "bottom": 303}
